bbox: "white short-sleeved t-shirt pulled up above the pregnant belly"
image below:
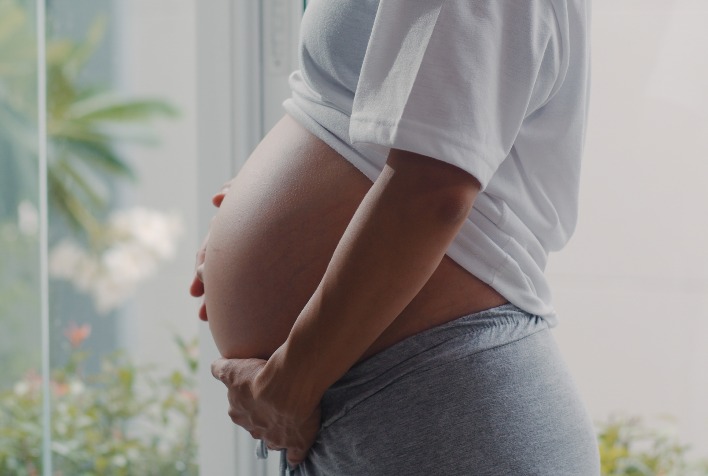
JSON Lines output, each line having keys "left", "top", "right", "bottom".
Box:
{"left": 284, "top": 0, "right": 590, "bottom": 325}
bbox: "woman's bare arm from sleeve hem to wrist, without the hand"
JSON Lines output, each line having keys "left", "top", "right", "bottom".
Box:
{"left": 268, "top": 151, "right": 479, "bottom": 410}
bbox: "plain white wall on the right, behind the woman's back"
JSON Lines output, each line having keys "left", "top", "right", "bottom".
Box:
{"left": 548, "top": 0, "right": 708, "bottom": 455}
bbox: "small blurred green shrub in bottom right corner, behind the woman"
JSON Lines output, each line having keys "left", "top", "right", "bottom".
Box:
{"left": 598, "top": 417, "right": 708, "bottom": 476}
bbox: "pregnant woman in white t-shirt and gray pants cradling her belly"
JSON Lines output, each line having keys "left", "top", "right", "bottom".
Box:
{"left": 191, "top": 0, "right": 599, "bottom": 476}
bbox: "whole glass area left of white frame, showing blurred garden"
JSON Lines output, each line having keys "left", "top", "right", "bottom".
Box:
{"left": 0, "top": 0, "right": 198, "bottom": 475}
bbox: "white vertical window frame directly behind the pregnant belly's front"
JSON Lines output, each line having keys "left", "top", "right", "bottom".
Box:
{"left": 195, "top": 0, "right": 306, "bottom": 476}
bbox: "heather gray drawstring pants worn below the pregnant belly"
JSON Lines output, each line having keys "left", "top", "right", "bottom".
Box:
{"left": 276, "top": 304, "right": 600, "bottom": 476}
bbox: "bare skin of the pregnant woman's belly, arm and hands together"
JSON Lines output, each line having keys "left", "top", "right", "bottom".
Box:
{"left": 192, "top": 113, "right": 506, "bottom": 464}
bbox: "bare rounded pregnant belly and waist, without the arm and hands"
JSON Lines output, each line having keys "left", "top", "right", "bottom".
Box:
{"left": 204, "top": 116, "right": 506, "bottom": 358}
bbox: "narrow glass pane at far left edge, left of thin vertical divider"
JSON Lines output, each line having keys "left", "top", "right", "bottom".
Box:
{"left": 0, "top": 0, "right": 43, "bottom": 475}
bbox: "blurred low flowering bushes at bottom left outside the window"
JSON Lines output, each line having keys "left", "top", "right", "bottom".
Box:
{"left": 0, "top": 332, "right": 198, "bottom": 476}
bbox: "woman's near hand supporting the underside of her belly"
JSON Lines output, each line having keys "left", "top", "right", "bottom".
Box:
{"left": 211, "top": 359, "right": 320, "bottom": 466}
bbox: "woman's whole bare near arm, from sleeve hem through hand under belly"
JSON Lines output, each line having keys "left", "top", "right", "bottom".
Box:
{"left": 212, "top": 150, "right": 480, "bottom": 463}
